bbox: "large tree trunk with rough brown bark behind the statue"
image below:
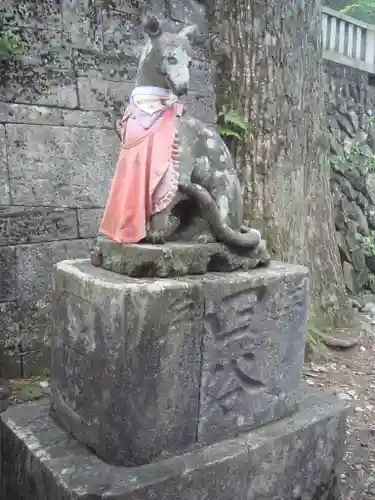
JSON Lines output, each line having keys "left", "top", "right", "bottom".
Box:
{"left": 209, "top": 0, "right": 352, "bottom": 320}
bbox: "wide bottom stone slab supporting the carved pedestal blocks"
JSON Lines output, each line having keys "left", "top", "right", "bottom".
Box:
{"left": 0, "top": 387, "right": 346, "bottom": 500}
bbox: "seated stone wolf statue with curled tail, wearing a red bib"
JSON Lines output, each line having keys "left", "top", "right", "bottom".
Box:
{"left": 100, "top": 16, "right": 261, "bottom": 251}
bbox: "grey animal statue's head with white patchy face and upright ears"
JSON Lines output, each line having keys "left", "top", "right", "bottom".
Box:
{"left": 137, "top": 16, "right": 198, "bottom": 97}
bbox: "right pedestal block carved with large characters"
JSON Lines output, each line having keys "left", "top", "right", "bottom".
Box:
{"left": 198, "top": 264, "right": 308, "bottom": 443}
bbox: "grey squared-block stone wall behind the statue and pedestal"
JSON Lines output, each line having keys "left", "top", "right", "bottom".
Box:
{"left": 0, "top": 0, "right": 216, "bottom": 377}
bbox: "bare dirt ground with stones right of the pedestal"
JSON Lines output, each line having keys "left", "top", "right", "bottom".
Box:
{"left": 304, "top": 315, "right": 375, "bottom": 500}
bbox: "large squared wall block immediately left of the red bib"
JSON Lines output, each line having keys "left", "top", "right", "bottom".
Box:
{"left": 7, "top": 124, "right": 119, "bottom": 208}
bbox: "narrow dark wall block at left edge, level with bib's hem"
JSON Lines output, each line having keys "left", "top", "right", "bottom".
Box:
{"left": 0, "top": 207, "right": 78, "bottom": 246}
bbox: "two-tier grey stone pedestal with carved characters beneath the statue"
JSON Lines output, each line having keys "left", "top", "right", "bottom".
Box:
{"left": 0, "top": 261, "right": 346, "bottom": 500}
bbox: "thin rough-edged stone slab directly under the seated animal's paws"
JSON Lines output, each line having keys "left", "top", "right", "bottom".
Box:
{"left": 91, "top": 236, "right": 270, "bottom": 278}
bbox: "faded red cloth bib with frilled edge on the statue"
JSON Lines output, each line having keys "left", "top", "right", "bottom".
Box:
{"left": 100, "top": 105, "right": 179, "bottom": 243}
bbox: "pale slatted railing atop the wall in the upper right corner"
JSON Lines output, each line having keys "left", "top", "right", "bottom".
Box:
{"left": 322, "top": 7, "right": 375, "bottom": 74}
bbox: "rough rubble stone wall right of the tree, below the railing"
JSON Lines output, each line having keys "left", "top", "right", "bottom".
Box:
{"left": 325, "top": 62, "right": 375, "bottom": 293}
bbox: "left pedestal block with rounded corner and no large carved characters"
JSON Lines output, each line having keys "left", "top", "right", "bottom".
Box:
{"left": 52, "top": 261, "right": 203, "bottom": 464}
